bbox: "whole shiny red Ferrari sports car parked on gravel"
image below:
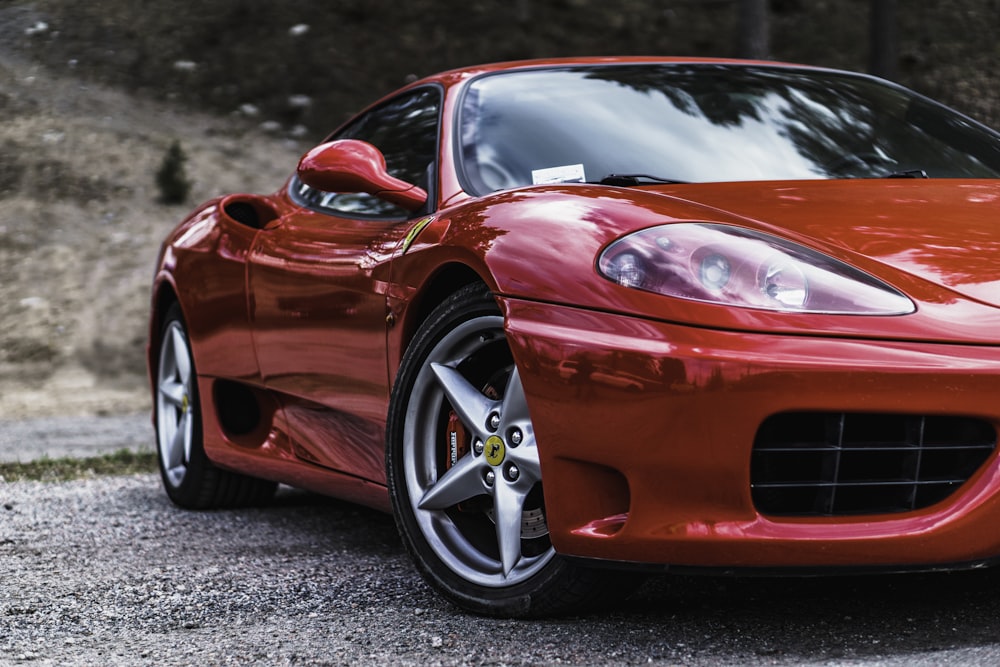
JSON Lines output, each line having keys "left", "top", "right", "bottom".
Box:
{"left": 149, "top": 58, "right": 1000, "bottom": 616}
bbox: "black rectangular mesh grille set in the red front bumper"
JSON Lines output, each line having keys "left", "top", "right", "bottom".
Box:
{"left": 750, "top": 412, "right": 996, "bottom": 516}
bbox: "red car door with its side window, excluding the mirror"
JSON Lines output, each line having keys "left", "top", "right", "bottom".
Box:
{"left": 247, "top": 88, "right": 440, "bottom": 481}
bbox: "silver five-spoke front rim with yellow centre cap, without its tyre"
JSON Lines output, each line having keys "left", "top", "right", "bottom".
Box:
{"left": 402, "top": 315, "right": 555, "bottom": 588}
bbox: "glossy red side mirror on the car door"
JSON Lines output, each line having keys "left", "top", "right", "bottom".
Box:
{"left": 297, "top": 139, "right": 427, "bottom": 211}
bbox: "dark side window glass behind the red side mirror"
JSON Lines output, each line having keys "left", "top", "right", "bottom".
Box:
{"left": 292, "top": 88, "right": 441, "bottom": 218}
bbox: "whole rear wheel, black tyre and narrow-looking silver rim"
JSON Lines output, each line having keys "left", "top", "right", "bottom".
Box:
{"left": 154, "top": 303, "right": 277, "bottom": 509}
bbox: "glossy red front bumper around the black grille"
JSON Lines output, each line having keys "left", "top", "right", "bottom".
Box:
{"left": 504, "top": 299, "right": 1000, "bottom": 568}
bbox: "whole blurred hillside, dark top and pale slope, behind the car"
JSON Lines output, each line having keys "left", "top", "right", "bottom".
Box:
{"left": 0, "top": 0, "right": 1000, "bottom": 420}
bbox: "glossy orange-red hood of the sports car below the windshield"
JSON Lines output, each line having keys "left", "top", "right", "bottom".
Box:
{"left": 669, "top": 179, "right": 1000, "bottom": 306}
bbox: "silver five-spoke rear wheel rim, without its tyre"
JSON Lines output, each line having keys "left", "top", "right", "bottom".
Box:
{"left": 156, "top": 320, "right": 196, "bottom": 489}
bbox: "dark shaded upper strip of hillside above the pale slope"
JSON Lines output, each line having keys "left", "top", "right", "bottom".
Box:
{"left": 0, "top": 0, "right": 1000, "bottom": 138}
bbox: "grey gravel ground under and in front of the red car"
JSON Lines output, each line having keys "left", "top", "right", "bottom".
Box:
{"left": 0, "top": 475, "right": 1000, "bottom": 665}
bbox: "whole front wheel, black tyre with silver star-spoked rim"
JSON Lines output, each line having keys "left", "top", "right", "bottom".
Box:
{"left": 386, "top": 284, "right": 632, "bottom": 618}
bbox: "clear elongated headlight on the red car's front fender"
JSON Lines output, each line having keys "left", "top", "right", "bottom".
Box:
{"left": 597, "top": 223, "right": 916, "bottom": 315}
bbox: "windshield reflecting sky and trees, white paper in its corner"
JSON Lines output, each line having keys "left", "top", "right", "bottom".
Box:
{"left": 459, "top": 64, "right": 1000, "bottom": 194}
